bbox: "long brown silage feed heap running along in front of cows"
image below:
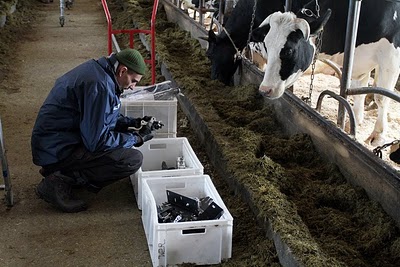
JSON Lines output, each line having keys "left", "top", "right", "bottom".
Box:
{"left": 109, "top": 0, "right": 400, "bottom": 267}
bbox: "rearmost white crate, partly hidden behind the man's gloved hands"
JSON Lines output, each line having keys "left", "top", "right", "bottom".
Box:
{"left": 120, "top": 98, "right": 178, "bottom": 138}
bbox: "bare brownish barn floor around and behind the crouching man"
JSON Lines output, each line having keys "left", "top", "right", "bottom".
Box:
{"left": 0, "top": 0, "right": 151, "bottom": 266}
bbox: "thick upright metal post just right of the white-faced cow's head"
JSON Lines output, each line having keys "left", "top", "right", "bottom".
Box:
{"left": 337, "top": 0, "right": 362, "bottom": 129}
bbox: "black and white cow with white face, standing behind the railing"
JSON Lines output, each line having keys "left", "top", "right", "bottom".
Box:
{"left": 253, "top": 0, "right": 400, "bottom": 145}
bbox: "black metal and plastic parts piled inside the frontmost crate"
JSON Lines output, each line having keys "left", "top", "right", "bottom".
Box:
{"left": 157, "top": 190, "right": 224, "bottom": 223}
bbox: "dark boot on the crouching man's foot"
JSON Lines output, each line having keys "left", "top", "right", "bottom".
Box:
{"left": 36, "top": 174, "right": 87, "bottom": 212}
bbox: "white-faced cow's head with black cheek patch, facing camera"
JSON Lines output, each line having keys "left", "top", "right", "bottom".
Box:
{"left": 252, "top": 11, "right": 330, "bottom": 98}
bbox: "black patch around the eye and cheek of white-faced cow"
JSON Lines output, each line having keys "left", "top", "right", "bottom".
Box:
{"left": 279, "top": 30, "right": 314, "bottom": 81}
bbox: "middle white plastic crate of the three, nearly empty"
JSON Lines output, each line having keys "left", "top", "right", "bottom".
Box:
{"left": 130, "top": 137, "right": 204, "bottom": 209}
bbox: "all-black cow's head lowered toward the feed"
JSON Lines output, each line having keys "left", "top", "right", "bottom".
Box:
{"left": 206, "top": 29, "right": 240, "bottom": 85}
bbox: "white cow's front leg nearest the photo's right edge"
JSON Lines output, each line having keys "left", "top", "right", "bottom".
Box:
{"left": 366, "top": 63, "right": 400, "bottom": 146}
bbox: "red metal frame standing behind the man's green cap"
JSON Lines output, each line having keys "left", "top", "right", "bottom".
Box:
{"left": 101, "top": 0, "right": 159, "bottom": 84}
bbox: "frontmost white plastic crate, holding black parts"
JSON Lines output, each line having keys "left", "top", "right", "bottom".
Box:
{"left": 142, "top": 175, "right": 233, "bottom": 267}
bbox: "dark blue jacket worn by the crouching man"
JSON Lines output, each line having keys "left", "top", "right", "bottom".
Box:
{"left": 31, "top": 55, "right": 140, "bottom": 166}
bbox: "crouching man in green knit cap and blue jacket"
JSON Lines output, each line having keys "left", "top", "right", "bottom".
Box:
{"left": 31, "top": 49, "right": 153, "bottom": 212}
